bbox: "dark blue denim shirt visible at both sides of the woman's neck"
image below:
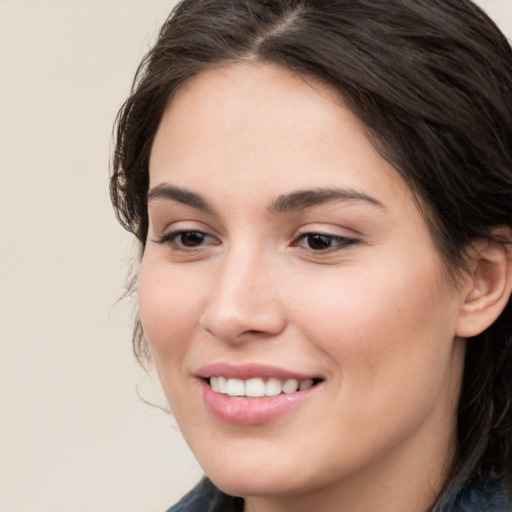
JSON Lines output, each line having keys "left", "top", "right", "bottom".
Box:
{"left": 167, "top": 478, "right": 512, "bottom": 512}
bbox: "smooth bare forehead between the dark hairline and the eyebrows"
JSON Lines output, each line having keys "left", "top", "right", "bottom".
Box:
{"left": 150, "top": 63, "right": 420, "bottom": 218}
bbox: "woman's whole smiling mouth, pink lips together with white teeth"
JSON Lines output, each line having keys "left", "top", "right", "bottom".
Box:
{"left": 197, "top": 363, "right": 322, "bottom": 425}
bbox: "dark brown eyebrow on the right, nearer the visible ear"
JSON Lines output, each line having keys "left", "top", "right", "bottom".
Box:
{"left": 268, "top": 188, "right": 386, "bottom": 213}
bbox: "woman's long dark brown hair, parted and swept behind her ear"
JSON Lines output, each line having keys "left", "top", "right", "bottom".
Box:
{"left": 110, "top": 0, "right": 512, "bottom": 510}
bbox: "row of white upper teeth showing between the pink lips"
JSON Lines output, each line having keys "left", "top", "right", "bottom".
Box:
{"left": 210, "top": 377, "right": 314, "bottom": 398}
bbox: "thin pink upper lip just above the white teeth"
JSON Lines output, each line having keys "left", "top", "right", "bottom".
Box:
{"left": 196, "top": 362, "right": 320, "bottom": 381}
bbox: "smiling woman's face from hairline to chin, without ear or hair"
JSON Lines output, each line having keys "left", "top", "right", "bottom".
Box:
{"left": 139, "top": 64, "right": 463, "bottom": 508}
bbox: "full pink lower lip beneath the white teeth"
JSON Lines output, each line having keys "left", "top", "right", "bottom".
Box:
{"left": 201, "top": 380, "right": 318, "bottom": 425}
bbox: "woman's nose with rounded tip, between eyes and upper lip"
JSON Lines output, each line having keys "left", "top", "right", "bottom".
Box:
{"left": 200, "top": 250, "right": 286, "bottom": 343}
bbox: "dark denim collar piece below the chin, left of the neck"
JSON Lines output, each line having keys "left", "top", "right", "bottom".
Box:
{"left": 167, "top": 478, "right": 243, "bottom": 512}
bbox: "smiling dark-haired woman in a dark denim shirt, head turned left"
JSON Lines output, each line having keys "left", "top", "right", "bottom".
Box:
{"left": 111, "top": 0, "right": 512, "bottom": 512}
